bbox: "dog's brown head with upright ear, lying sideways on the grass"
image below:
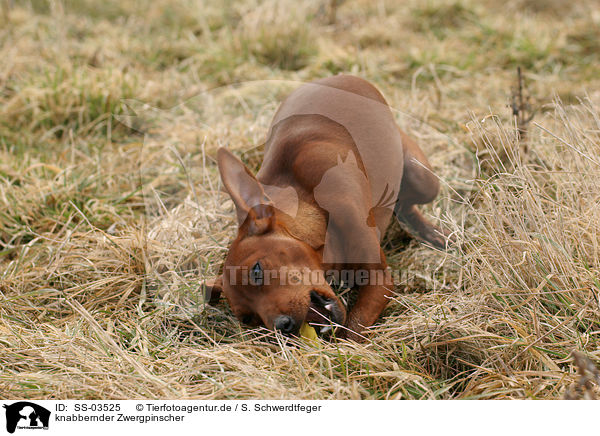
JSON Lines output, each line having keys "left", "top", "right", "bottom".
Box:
{"left": 211, "top": 148, "right": 346, "bottom": 334}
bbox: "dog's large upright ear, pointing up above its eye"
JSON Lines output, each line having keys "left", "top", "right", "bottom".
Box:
{"left": 217, "top": 148, "right": 274, "bottom": 234}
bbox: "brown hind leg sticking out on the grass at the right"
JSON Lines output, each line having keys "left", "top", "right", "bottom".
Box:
{"left": 394, "top": 133, "right": 448, "bottom": 249}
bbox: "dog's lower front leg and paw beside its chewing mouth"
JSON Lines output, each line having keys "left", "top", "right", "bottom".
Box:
{"left": 340, "top": 265, "right": 394, "bottom": 342}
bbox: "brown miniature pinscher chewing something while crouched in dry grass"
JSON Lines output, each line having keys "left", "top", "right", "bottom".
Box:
{"left": 207, "top": 75, "right": 446, "bottom": 340}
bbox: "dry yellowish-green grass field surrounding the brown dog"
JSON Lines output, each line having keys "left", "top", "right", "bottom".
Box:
{"left": 0, "top": 0, "right": 600, "bottom": 399}
